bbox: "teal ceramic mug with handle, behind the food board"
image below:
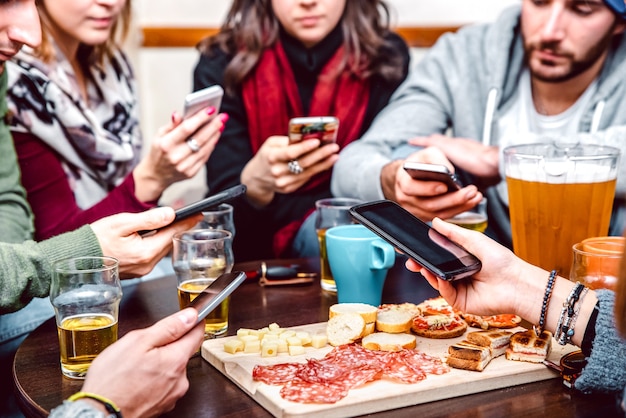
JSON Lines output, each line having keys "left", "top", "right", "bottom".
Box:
{"left": 326, "top": 225, "right": 396, "bottom": 306}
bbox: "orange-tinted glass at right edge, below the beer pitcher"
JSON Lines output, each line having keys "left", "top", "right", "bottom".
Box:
{"left": 569, "top": 237, "right": 626, "bottom": 291}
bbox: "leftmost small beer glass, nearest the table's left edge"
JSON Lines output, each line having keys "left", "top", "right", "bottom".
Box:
{"left": 50, "top": 257, "right": 122, "bottom": 379}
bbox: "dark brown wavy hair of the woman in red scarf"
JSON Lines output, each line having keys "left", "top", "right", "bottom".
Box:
{"left": 198, "top": 0, "right": 402, "bottom": 90}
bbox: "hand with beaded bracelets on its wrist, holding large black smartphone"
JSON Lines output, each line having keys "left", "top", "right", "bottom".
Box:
{"left": 406, "top": 218, "right": 547, "bottom": 318}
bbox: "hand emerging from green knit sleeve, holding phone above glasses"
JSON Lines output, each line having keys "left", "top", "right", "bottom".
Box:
{"left": 91, "top": 207, "right": 202, "bottom": 278}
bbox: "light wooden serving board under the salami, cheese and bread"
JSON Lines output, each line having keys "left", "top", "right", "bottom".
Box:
{"left": 202, "top": 322, "right": 576, "bottom": 417}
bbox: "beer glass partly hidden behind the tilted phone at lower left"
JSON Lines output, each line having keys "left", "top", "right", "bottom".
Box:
{"left": 172, "top": 229, "right": 235, "bottom": 339}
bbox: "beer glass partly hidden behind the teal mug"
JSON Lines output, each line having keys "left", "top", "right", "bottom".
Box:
{"left": 315, "top": 197, "right": 362, "bottom": 292}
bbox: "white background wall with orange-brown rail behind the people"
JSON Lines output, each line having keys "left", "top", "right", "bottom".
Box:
{"left": 128, "top": 0, "right": 521, "bottom": 207}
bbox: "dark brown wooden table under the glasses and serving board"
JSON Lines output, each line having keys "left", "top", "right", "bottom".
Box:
{"left": 13, "top": 259, "right": 623, "bottom": 418}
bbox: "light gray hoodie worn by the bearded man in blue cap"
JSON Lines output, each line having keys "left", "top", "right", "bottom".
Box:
{"left": 331, "top": 6, "right": 626, "bottom": 246}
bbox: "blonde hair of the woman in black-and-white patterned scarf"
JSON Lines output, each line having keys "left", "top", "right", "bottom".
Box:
{"left": 35, "top": 0, "right": 132, "bottom": 65}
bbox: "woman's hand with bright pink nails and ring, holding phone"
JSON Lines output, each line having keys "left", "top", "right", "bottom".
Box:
{"left": 133, "top": 107, "right": 228, "bottom": 202}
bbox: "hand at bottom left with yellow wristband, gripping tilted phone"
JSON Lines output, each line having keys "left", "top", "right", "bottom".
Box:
{"left": 82, "top": 308, "right": 204, "bottom": 418}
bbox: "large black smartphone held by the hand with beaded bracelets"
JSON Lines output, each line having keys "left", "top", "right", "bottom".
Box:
{"left": 350, "top": 200, "right": 482, "bottom": 280}
